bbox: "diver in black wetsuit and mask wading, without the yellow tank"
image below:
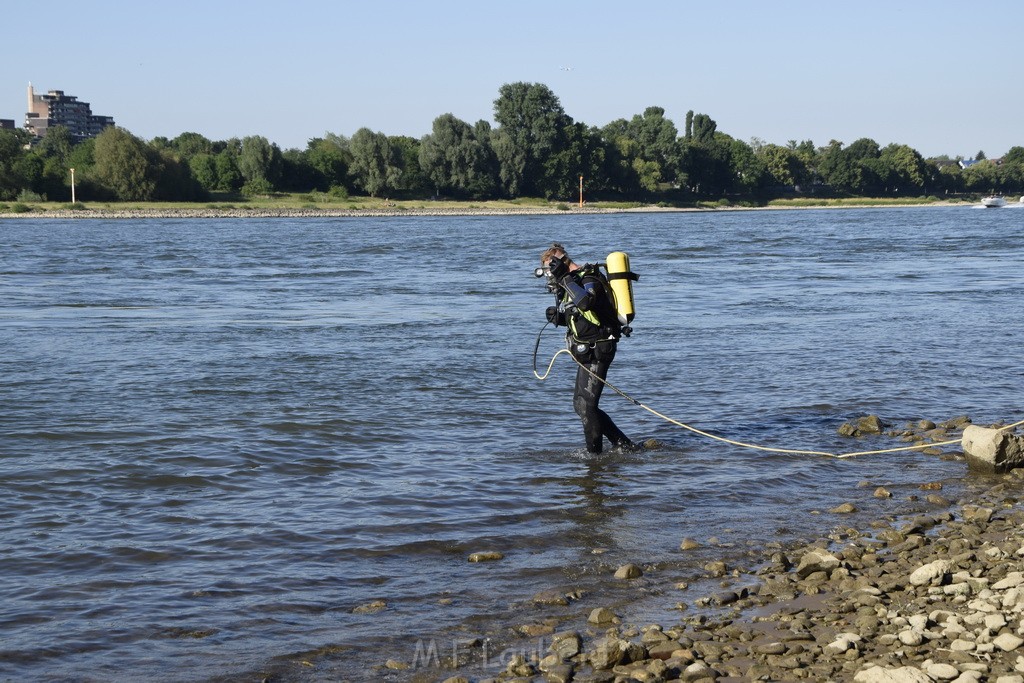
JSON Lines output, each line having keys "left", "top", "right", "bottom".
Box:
{"left": 539, "top": 243, "right": 636, "bottom": 454}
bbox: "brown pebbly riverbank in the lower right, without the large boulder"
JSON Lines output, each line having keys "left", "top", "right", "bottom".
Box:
{"left": 382, "top": 419, "right": 1024, "bottom": 683}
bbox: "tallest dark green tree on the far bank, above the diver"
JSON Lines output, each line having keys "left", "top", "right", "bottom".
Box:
{"left": 494, "top": 82, "right": 572, "bottom": 197}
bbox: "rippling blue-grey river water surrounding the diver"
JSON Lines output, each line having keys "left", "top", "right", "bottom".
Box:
{"left": 0, "top": 207, "right": 1024, "bottom": 681}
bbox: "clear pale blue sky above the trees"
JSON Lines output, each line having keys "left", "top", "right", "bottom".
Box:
{"left": 0, "top": 0, "right": 1024, "bottom": 158}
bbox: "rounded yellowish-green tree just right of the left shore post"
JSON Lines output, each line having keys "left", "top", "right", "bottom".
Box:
{"left": 93, "top": 126, "right": 163, "bottom": 202}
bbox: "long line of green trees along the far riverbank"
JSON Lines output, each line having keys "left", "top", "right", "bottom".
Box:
{"left": 0, "top": 82, "right": 1024, "bottom": 203}
